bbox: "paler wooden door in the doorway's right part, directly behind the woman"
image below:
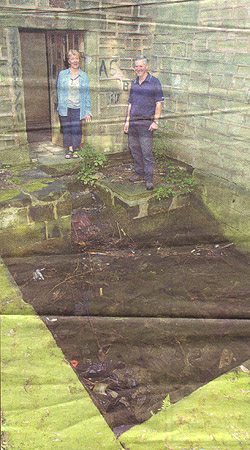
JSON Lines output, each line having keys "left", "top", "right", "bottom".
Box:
{"left": 46, "top": 30, "right": 84, "bottom": 146}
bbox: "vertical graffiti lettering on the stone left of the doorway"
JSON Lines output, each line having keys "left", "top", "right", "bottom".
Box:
{"left": 10, "top": 30, "right": 24, "bottom": 123}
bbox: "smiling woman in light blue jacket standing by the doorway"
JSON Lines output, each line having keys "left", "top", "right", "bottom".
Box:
{"left": 57, "top": 50, "right": 92, "bottom": 159}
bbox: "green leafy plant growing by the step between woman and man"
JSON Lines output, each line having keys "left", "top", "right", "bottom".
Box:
{"left": 77, "top": 144, "right": 107, "bottom": 186}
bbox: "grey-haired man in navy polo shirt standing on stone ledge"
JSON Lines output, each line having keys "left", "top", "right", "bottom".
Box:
{"left": 124, "top": 56, "right": 164, "bottom": 190}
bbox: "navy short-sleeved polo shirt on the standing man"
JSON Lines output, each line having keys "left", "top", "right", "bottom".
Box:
{"left": 128, "top": 73, "right": 164, "bottom": 119}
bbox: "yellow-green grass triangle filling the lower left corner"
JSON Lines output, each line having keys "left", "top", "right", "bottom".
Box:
{"left": 0, "top": 263, "right": 120, "bottom": 450}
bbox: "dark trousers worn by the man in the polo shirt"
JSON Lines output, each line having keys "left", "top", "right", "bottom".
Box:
{"left": 128, "top": 118, "right": 154, "bottom": 183}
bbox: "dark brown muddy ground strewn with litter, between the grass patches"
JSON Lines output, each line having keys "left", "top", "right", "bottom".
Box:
{"left": 6, "top": 238, "right": 250, "bottom": 434}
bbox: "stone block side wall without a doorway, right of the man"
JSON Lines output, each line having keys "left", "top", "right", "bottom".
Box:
{"left": 152, "top": 0, "right": 250, "bottom": 188}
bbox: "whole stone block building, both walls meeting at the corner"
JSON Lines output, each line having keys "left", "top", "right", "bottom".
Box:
{"left": 0, "top": 0, "right": 250, "bottom": 250}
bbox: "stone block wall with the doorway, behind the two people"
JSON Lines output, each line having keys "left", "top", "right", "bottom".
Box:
{"left": 0, "top": 0, "right": 154, "bottom": 164}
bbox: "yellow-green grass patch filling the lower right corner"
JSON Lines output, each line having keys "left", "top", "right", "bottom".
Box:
{"left": 120, "top": 369, "right": 250, "bottom": 450}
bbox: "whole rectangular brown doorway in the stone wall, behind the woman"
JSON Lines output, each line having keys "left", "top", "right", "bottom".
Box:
{"left": 20, "top": 30, "right": 84, "bottom": 146}
